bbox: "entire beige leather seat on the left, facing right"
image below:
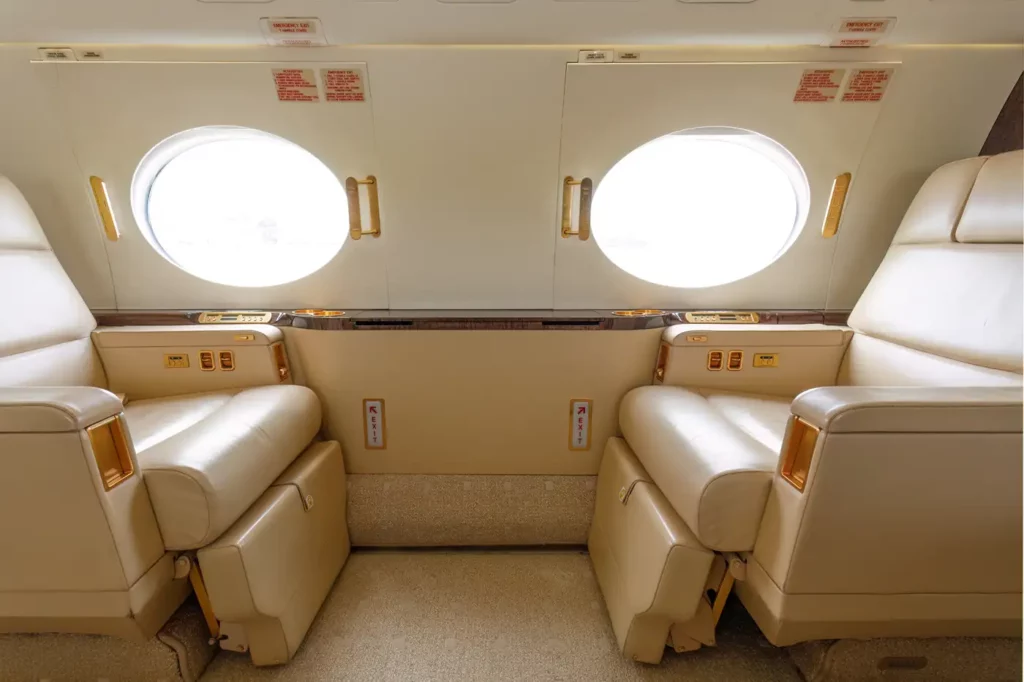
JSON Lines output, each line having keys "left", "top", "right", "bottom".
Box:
{"left": 0, "top": 176, "right": 348, "bottom": 664}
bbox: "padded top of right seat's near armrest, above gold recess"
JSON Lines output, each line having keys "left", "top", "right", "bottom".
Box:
{"left": 793, "top": 386, "right": 1024, "bottom": 433}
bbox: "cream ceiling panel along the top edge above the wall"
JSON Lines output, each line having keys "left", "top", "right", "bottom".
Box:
{"left": 0, "top": 0, "right": 1024, "bottom": 45}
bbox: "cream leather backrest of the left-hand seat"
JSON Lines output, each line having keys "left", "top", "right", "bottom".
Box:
{"left": 0, "top": 175, "right": 106, "bottom": 388}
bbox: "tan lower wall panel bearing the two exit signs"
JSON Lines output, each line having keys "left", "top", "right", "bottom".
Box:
{"left": 285, "top": 328, "right": 662, "bottom": 475}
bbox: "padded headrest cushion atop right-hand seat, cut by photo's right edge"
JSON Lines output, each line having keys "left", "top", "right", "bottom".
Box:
{"left": 953, "top": 152, "right": 1024, "bottom": 244}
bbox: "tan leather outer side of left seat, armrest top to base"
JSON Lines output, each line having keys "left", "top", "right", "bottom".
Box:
{"left": 0, "top": 387, "right": 188, "bottom": 637}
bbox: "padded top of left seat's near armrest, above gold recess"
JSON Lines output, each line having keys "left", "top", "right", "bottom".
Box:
{"left": 0, "top": 386, "right": 124, "bottom": 433}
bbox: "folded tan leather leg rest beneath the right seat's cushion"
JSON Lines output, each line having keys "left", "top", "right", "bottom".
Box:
{"left": 588, "top": 438, "right": 715, "bottom": 664}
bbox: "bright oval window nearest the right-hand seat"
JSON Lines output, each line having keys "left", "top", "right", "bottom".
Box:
{"left": 591, "top": 128, "right": 810, "bottom": 289}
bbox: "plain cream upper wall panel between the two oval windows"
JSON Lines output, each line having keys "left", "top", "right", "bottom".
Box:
{"left": 371, "top": 50, "right": 575, "bottom": 309}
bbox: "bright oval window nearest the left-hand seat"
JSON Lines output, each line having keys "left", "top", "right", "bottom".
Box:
{"left": 131, "top": 127, "right": 348, "bottom": 287}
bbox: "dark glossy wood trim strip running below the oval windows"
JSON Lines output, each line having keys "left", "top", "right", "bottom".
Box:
{"left": 93, "top": 310, "right": 850, "bottom": 331}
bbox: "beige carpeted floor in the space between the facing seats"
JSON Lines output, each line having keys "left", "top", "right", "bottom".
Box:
{"left": 202, "top": 551, "right": 801, "bottom": 682}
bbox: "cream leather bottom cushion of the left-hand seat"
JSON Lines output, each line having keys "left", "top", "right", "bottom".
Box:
{"left": 125, "top": 385, "right": 321, "bottom": 550}
